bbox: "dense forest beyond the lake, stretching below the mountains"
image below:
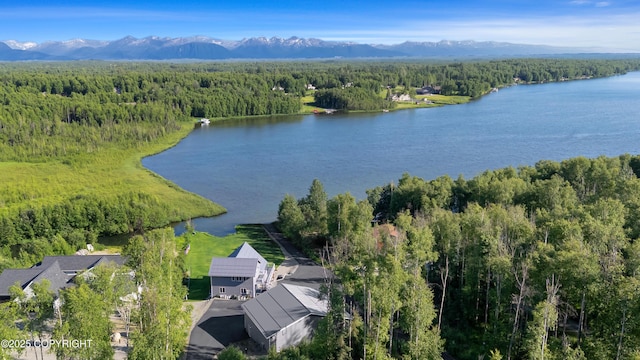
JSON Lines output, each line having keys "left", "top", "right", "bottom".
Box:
{"left": 0, "top": 59, "right": 640, "bottom": 161}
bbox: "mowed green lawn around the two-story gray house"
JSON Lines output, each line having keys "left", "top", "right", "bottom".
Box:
{"left": 177, "top": 225, "right": 284, "bottom": 300}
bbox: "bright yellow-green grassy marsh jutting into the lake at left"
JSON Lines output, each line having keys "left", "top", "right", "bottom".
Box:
{"left": 0, "top": 123, "right": 225, "bottom": 221}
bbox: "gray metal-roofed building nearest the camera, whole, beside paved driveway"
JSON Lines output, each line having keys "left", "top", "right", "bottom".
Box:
{"left": 242, "top": 284, "right": 328, "bottom": 352}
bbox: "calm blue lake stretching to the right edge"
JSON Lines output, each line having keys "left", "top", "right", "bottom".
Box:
{"left": 142, "top": 72, "right": 640, "bottom": 235}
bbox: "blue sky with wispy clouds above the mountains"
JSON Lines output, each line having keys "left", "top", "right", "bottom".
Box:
{"left": 0, "top": 0, "right": 640, "bottom": 51}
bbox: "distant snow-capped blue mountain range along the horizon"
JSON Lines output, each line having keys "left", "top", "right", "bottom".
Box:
{"left": 0, "top": 36, "right": 620, "bottom": 61}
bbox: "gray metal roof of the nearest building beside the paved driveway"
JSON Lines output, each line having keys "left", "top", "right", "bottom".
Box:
{"left": 242, "top": 284, "right": 328, "bottom": 338}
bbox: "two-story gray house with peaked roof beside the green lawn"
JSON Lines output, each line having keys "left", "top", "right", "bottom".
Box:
{"left": 209, "top": 242, "right": 275, "bottom": 299}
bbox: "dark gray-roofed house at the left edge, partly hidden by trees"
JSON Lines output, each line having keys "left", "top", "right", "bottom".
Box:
{"left": 0, "top": 255, "right": 124, "bottom": 301}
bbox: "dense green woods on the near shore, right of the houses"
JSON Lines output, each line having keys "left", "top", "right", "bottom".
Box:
{"left": 278, "top": 155, "right": 640, "bottom": 359}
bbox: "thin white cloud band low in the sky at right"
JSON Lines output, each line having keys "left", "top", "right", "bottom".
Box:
{"left": 301, "top": 13, "right": 640, "bottom": 52}
